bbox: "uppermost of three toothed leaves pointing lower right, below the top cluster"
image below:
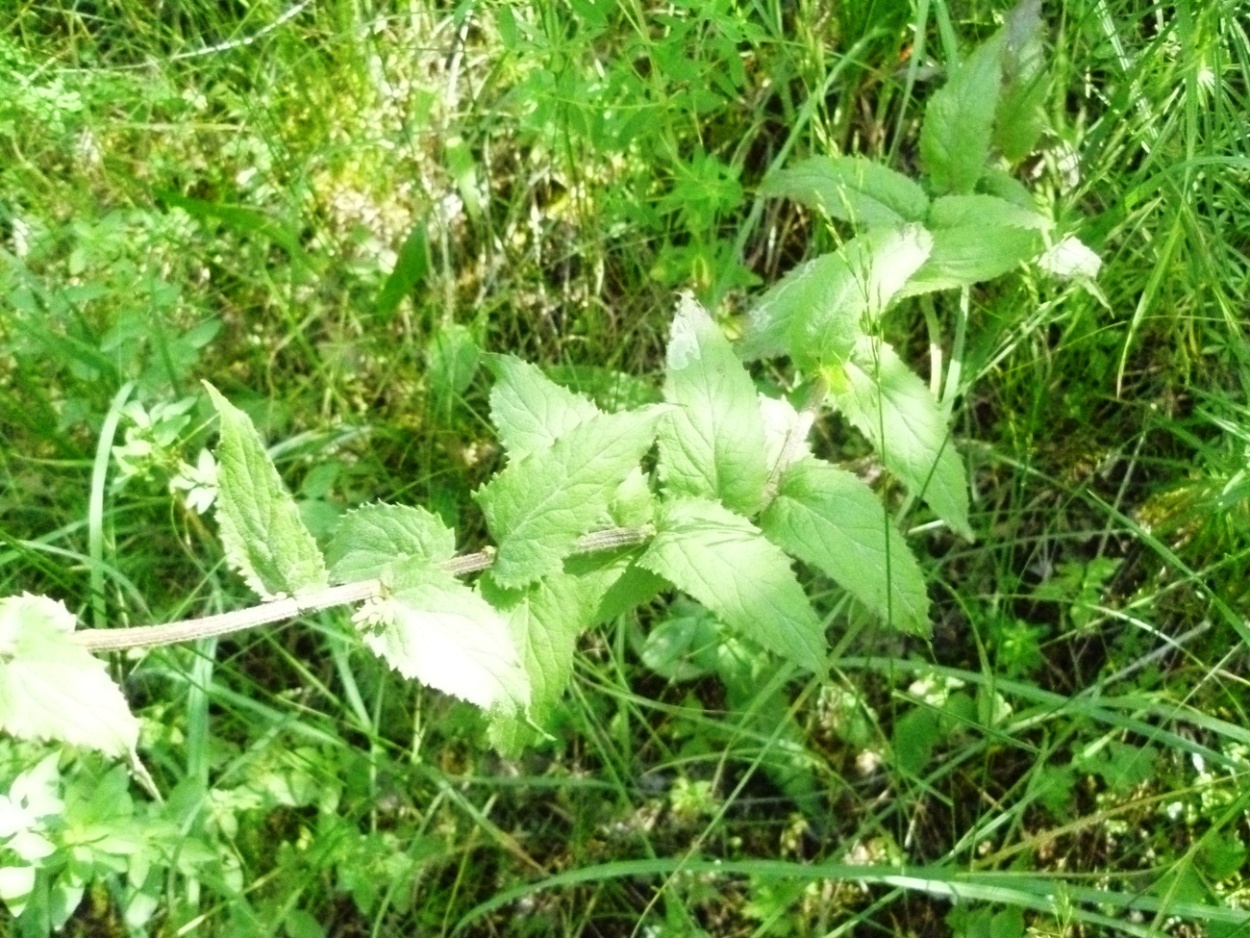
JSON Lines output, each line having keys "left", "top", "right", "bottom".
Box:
{"left": 830, "top": 339, "right": 973, "bottom": 540}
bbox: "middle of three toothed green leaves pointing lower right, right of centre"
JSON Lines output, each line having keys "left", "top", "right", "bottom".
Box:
{"left": 760, "top": 459, "right": 930, "bottom": 635}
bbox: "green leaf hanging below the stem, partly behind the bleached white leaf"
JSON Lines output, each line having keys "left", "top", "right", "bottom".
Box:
{"left": 480, "top": 573, "right": 605, "bottom": 753}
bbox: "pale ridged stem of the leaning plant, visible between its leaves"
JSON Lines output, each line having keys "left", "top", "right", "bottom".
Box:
{"left": 74, "top": 525, "right": 655, "bottom": 652}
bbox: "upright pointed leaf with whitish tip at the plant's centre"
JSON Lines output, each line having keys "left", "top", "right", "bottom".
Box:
{"left": 656, "top": 293, "right": 769, "bottom": 515}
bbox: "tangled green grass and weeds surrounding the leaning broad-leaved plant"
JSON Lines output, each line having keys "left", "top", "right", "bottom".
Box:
{"left": 0, "top": 0, "right": 1250, "bottom": 938}
